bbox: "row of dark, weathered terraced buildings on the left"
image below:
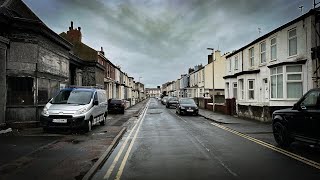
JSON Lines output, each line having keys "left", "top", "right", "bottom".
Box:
{"left": 0, "top": 0, "right": 144, "bottom": 125}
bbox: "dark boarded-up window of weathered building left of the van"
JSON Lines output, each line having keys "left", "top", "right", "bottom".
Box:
{"left": 7, "top": 77, "right": 34, "bottom": 105}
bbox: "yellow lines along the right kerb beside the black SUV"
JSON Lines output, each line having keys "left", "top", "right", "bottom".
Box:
{"left": 211, "top": 123, "right": 320, "bottom": 169}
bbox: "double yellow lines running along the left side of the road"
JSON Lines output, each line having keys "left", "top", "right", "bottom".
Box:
{"left": 103, "top": 102, "right": 149, "bottom": 180}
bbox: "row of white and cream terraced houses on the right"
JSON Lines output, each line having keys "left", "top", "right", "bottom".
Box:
{"left": 162, "top": 9, "right": 320, "bottom": 121}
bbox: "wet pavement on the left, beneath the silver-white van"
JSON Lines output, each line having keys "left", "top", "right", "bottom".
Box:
{"left": 0, "top": 101, "right": 146, "bottom": 180}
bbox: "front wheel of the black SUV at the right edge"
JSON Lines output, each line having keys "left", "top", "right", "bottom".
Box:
{"left": 272, "top": 122, "right": 292, "bottom": 148}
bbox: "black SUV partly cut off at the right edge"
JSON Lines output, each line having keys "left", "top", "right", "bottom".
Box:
{"left": 272, "top": 88, "right": 320, "bottom": 147}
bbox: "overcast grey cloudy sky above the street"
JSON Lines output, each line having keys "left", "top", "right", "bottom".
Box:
{"left": 24, "top": 0, "right": 313, "bottom": 87}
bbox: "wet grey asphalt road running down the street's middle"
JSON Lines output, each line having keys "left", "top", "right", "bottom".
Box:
{"left": 93, "top": 99, "right": 320, "bottom": 180}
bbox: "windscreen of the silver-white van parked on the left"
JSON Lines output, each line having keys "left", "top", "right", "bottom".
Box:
{"left": 51, "top": 90, "right": 93, "bottom": 105}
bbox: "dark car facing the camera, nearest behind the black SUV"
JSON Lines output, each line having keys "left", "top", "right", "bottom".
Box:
{"left": 176, "top": 98, "right": 199, "bottom": 116}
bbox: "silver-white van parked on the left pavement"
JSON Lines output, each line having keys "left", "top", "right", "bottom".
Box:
{"left": 40, "top": 88, "right": 108, "bottom": 132}
